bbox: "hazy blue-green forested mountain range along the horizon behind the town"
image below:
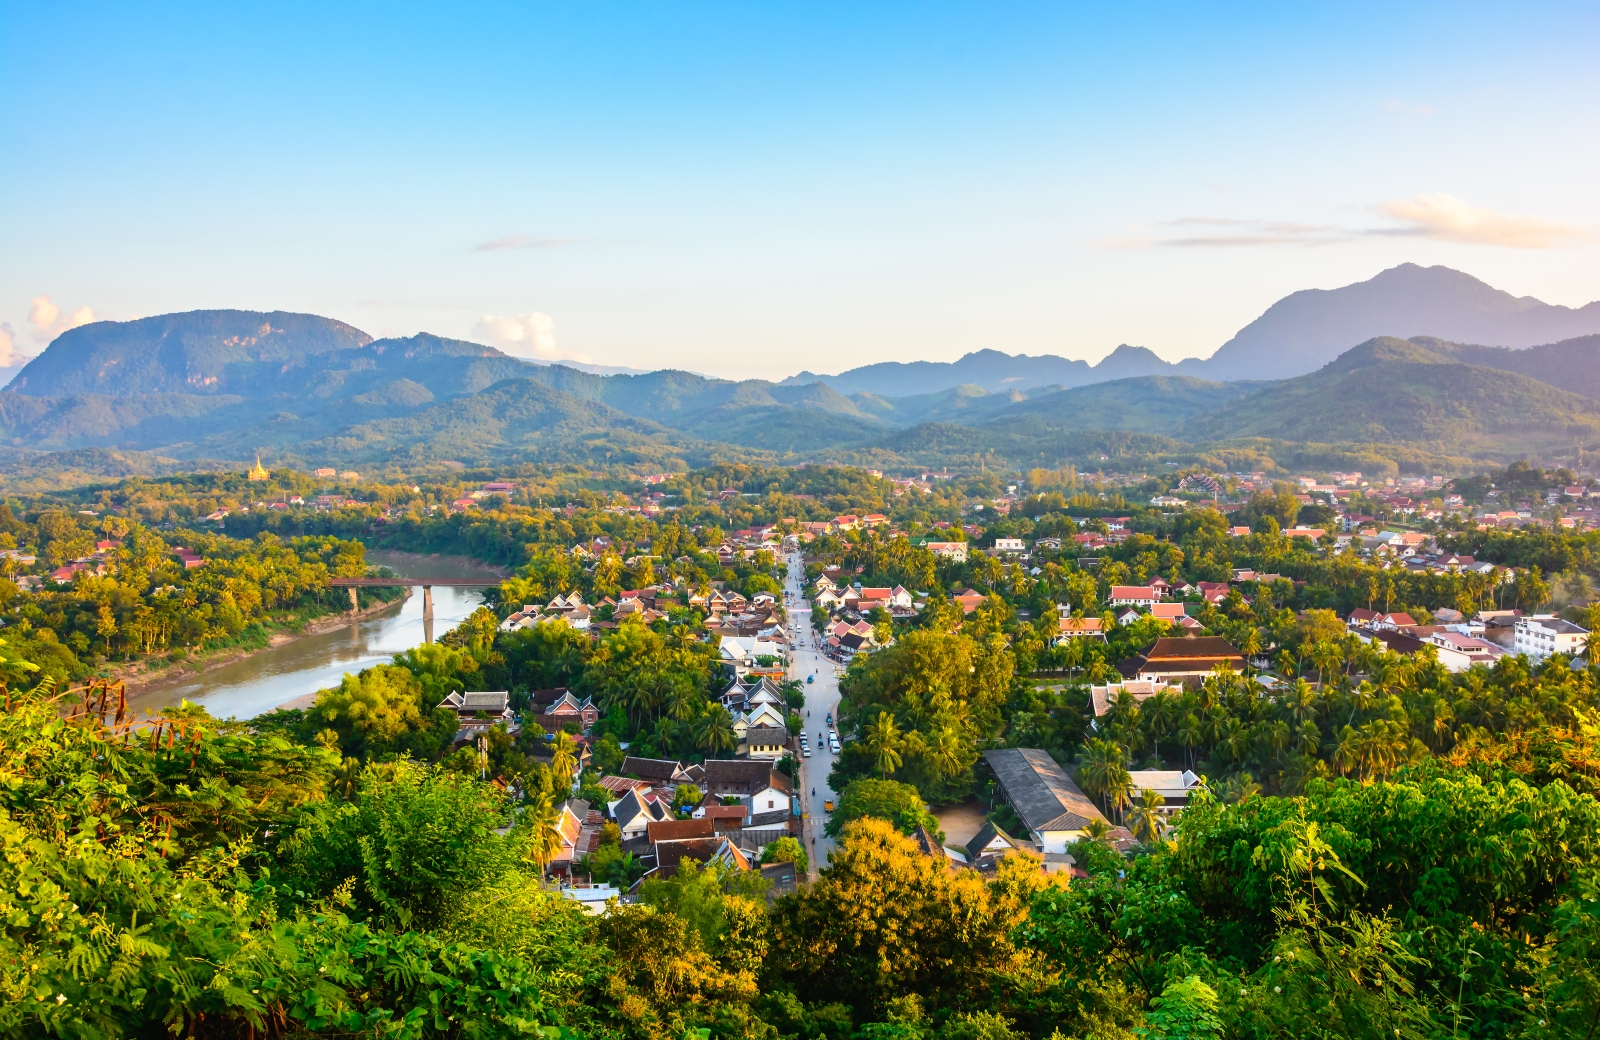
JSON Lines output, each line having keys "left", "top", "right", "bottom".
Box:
{"left": 9, "top": 267, "right": 1600, "bottom": 477}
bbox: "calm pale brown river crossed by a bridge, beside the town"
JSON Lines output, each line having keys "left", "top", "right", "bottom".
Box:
{"left": 128, "top": 550, "right": 496, "bottom": 718}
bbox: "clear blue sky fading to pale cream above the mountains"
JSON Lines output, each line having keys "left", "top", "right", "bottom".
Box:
{"left": 0, "top": 2, "right": 1600, "bottom": 376}
